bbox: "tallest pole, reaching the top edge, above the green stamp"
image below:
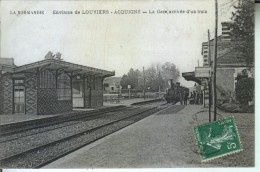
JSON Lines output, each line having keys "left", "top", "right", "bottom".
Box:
{"left": 213, "top": 0, "right": 218, "bottom": 121}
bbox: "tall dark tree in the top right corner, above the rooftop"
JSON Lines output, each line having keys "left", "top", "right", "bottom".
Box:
{"left": 231, "top": 0, "right": 255, "bottom": 65}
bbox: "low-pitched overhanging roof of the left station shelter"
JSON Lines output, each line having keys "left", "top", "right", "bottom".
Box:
{"left": 2, "top": 59, "right": 115, "bottom": 77}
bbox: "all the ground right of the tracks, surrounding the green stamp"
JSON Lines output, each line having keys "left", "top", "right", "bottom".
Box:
{"left": 45, "top": 105, "right": 254, "bottom": 168}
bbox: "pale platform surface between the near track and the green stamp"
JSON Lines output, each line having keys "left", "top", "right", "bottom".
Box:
{"left": 44, "top": 105, "right": 201, "bottom": 168}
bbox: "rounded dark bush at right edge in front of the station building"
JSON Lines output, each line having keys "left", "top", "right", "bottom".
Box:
{"left": 236, "top": 78, "right": 255, "bottom": 104}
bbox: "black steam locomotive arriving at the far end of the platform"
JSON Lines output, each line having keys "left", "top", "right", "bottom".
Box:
{"left": 165, "top": 79, "right": 189, "bottom": 104}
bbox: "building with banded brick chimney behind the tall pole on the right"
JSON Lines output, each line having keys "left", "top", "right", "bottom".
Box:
{"left": 202, "top": 22, "right": 253, "bottom": 94}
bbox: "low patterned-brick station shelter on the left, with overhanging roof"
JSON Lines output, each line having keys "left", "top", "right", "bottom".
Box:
{"left": 0, "top": 52, "right": 115, "bottom": 115}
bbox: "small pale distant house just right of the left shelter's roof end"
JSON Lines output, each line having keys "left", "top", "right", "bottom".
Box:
{"left": 103, "top": 77, "right": 122, "bottom": 94}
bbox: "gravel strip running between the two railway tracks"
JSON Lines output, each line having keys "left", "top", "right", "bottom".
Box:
{"left": 0, "top": 107, "right": 149, "bottom": 159}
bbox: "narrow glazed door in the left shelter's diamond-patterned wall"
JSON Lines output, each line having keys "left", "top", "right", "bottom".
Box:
{"left": 14, "top": 85, "right": 25, "bottom": 113}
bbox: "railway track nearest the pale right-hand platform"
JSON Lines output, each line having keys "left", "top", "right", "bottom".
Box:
{"left": 0, "top": 101, "right": 170, "bottom": 168}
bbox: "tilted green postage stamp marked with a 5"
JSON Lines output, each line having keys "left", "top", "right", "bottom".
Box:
{"left": 194, "top": 117, "right": 242, "bottom": 161}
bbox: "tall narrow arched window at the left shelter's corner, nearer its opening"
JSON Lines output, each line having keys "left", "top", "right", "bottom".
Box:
{"left": 57, "top": 73, "right": 71, "bottom": 100}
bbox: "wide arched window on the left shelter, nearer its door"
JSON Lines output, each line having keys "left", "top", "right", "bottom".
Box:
{"left": 39, "top": 70, "right": 56, "bottom": 88}
